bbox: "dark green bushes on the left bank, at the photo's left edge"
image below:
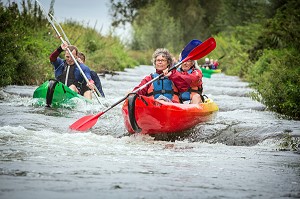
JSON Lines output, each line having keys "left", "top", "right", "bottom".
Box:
{"left": 0, "top": 0, "right": 53, "bottom": 86}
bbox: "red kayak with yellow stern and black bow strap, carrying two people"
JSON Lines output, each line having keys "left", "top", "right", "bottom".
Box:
{"left": 122, "top": 95, "right": 219, "bottom": 134}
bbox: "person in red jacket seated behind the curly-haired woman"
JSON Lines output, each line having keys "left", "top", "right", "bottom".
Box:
{"left": 178, "top": 60, "right": 203, "bottom": 104}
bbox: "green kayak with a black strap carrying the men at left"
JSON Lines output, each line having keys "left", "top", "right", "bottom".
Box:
{"left": 33, "top": 79, "right": 92, "bottom": 108}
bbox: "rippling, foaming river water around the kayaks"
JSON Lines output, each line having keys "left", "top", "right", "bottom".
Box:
{"left": 0, "top": 66, "right": 300, "bottom": 199}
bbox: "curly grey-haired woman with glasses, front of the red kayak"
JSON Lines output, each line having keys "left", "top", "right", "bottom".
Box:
{"left": 133, "top": 48, "right": 190, "bottom": 103}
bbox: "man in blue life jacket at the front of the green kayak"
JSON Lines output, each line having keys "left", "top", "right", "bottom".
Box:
{"left": 50, "top": 42, "right": 95, "bottom": 99}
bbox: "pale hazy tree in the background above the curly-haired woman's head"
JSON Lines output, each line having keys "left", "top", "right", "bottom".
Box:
{"left": 132, "top": 0, "right": 183, "bottom": 52}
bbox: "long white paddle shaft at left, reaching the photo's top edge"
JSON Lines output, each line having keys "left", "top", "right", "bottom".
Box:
{"left": 35, "top": 0, "right": 101, "bottom": 104}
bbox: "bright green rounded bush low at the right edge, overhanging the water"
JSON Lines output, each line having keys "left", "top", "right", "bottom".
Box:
{"left": 248, "top": 48, "right": 300, "bottom": 119}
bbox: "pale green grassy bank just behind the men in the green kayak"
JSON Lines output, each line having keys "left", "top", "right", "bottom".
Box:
{"left": 62, "top": 21, "right": 139, "bottom": 72}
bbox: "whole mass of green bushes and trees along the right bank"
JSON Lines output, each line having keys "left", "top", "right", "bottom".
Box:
{"left": 211, "top": 1, "right": 300, "bottom": 119}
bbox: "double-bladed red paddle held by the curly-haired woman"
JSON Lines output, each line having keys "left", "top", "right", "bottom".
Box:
{"left": 69, "top": 37, "right": 216, "bottom": 131}
